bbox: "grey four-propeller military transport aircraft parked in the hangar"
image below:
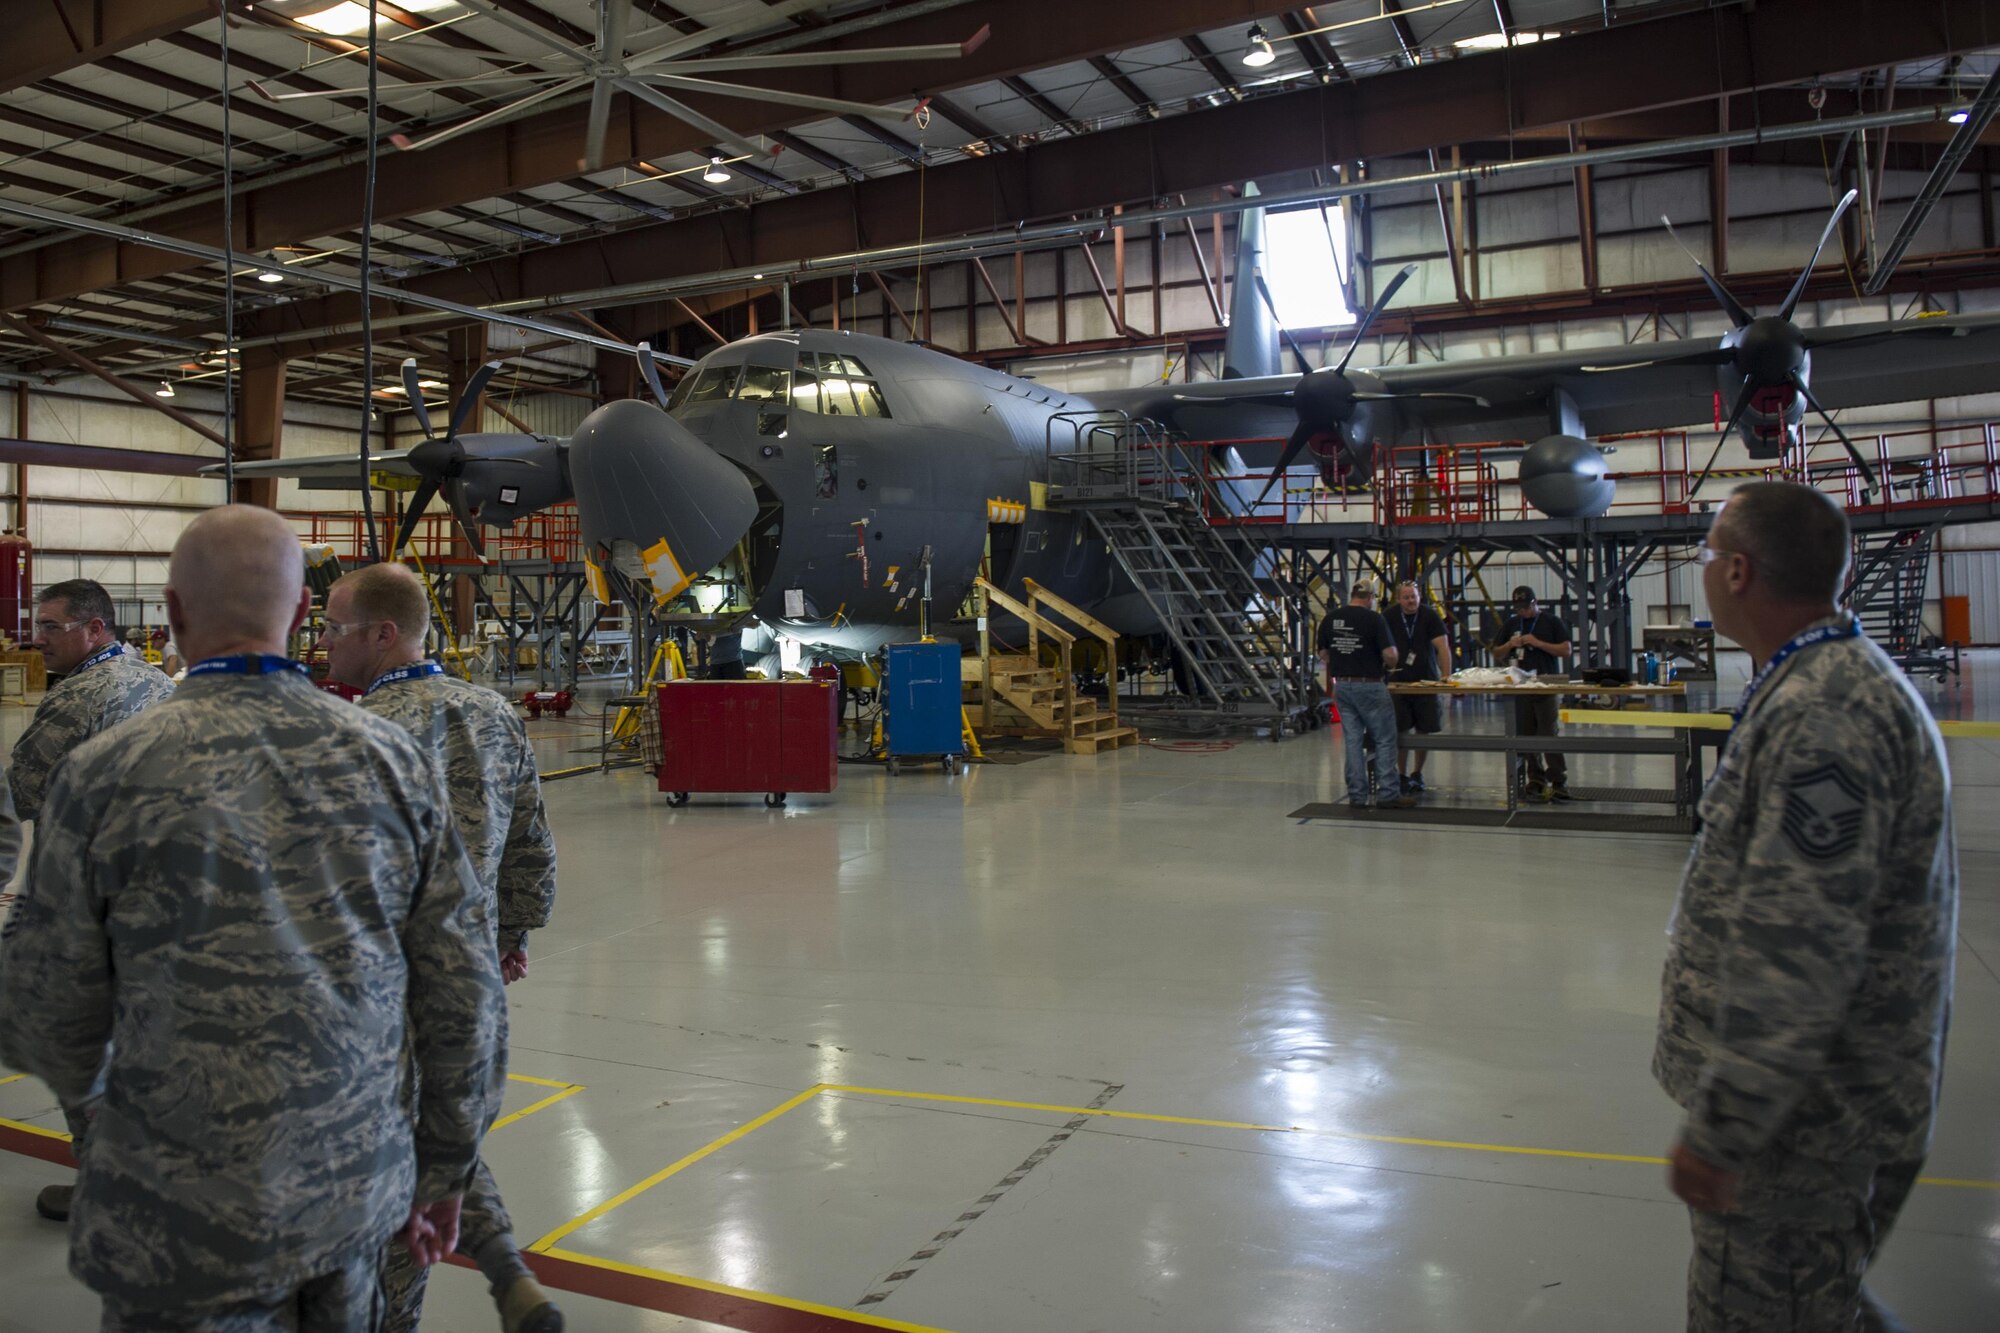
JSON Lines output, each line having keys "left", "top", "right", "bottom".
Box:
{"left": 223, "top": 187, "right": 2000, "bottom": 650}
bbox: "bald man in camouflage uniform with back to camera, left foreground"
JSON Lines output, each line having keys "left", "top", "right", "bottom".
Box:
{"left": 0, "top": 506, "right": 506, "bottom": 1333}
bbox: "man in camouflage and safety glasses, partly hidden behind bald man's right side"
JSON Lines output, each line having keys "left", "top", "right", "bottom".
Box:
{"left": 324, "top": 564, "right": 562, "bottom": 1333}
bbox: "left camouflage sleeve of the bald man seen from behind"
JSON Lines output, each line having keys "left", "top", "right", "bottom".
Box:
{"left": 0, "top": 756, "right": 112, "bottom": 1105}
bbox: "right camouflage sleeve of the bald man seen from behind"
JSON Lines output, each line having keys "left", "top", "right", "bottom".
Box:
{"left": 402, "top": 763, "right": 506, "bottom": 1203}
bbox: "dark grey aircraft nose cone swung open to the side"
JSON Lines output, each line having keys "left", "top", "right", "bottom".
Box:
{"left": 570, "top": 398, "right": 756, "bottom": 596}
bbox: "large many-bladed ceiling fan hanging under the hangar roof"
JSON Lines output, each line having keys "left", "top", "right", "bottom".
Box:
{"left": 250, "top": 0, "right": 988, "bottom": 170}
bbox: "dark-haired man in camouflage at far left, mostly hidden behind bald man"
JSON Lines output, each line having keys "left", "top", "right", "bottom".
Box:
{"left": 8, "top": 578, "right": 174, "bottom": 1221}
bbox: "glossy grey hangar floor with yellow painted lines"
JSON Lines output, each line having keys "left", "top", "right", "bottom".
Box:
{"left": 0, "top": 654, "right": 2000, "bottom": 1333}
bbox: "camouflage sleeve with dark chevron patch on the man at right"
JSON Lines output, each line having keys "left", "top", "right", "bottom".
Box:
{"left": 1682, "top": 707, "right": 1900, "bottom": 1169}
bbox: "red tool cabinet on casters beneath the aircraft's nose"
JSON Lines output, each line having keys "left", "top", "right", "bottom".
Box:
{"left": 658, "top": 681, "right": 840, "bottom": 807}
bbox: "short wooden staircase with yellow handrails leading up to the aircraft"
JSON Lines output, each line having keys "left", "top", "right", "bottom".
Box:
{"left": 964, "top": 578, "right": 1138, "bottom": 755}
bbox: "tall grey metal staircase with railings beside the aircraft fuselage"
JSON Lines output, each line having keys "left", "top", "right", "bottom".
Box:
{"left": 1048, "top": 414, "right": 1312, "bottom": 733}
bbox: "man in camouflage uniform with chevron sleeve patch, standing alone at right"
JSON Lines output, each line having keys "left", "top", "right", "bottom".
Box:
{"left": 1652, "top": 482, "right": 1958, "bottom": 1333}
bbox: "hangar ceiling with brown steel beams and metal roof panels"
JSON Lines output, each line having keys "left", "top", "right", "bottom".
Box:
{"left": 0, "top": 0, "right": 2000, "bottom": 404}
